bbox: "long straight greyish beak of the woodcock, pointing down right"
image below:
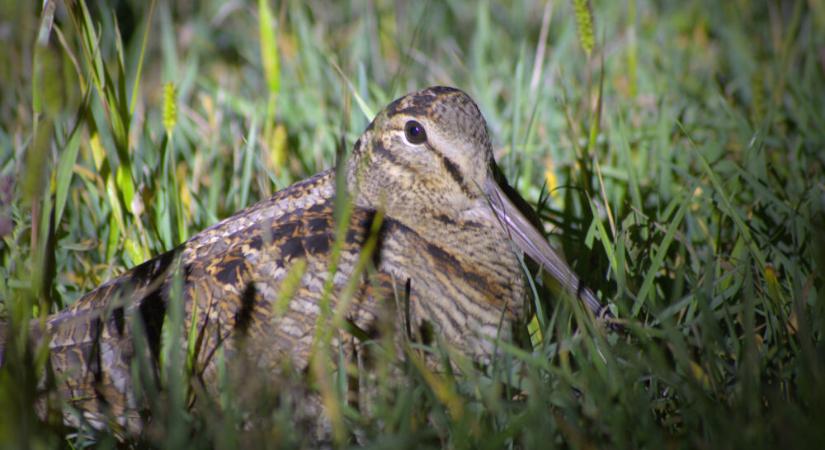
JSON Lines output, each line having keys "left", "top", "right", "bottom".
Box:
{"left": 484, "top": 178, "right": 609, "bottom": 318}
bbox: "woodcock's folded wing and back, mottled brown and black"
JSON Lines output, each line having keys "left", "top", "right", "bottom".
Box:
{"left": 35, "top": 171, "right": 386, "bottom": 432}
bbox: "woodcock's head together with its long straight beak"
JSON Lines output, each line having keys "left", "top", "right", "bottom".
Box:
{"left": 347, "top": 87, "right": 601, "bottom": 313}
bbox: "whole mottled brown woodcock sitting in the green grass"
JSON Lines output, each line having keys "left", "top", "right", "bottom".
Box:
{"left": 12, "top": 87, "right": 606, "bottom": 432}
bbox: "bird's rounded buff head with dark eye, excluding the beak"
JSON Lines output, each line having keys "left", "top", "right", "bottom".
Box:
{"left": 348, "top": 87, "right": 493, "bottom": 217}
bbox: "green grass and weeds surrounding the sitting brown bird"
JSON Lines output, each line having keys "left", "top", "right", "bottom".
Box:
{"left": 0, "top": 0, "right": 825, "bottom": 448}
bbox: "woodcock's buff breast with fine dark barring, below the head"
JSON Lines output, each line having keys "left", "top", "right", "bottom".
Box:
{"left": 380, "top": 215, "right": 524, "bottom": 360}
